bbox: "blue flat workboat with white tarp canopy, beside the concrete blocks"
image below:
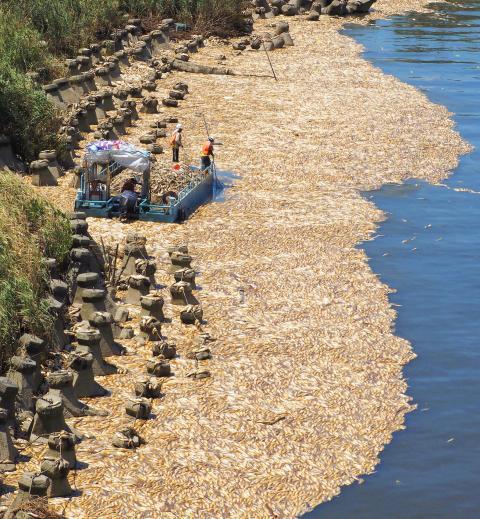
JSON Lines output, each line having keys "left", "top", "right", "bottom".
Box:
{"left": 75, "top": 141, "right": 216, "bottom": 223}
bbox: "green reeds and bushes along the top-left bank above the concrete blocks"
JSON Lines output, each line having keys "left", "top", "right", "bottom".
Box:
{"left": 0, "top": 0, "right": 245, "bottom": 161}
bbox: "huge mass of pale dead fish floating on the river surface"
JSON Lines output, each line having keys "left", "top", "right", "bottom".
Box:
{"left": 21, "top": 2, "right": 467, "bottom": 517}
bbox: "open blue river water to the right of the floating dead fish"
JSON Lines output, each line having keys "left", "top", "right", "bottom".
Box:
{"left": 304, "top": 0, "right": 480, "bottom": 519}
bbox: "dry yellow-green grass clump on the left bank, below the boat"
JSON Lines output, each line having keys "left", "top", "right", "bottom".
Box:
{"left": 0, "top": 171, "right": 71, "bottom": 366}
